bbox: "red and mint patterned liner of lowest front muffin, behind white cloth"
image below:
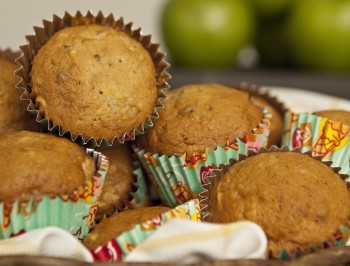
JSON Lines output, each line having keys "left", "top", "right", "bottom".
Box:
{"left": 91, "top": 200, "right": 201, "bottom": 262}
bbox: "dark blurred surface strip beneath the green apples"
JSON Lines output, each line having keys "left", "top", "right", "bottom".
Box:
{"left": 169, "top": 67, "right": 350, "bottom": 99}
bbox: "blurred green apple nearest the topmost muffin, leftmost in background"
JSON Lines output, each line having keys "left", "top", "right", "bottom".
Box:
{"left": 161, "top": 0, "right": 255, "bottom": 68}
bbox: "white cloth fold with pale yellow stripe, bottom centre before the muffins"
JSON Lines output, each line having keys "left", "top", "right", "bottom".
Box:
{"left": 125, "top": 219, "right": 267, "bottom": 263}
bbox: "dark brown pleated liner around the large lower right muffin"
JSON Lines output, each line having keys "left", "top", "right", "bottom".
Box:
{"left": 200, "top": 146, "right": 350, "bottom": 260}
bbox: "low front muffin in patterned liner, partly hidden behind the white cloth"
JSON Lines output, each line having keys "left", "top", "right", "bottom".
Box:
{"left": 83, "top": 200, "right": 201, "bottom": 262}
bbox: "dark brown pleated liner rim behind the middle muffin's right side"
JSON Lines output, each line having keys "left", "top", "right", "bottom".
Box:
{"left": 233, "top": 82, "right": 288, "bottom": 146}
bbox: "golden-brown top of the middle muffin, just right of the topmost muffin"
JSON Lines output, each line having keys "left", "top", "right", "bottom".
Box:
{"left": 138, "top": 84, "right": 263, "bottom": 155}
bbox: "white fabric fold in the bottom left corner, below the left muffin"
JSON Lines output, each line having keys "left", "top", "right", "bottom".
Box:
{"left": 0, "top": 227, "right": 93, "bottom": 262}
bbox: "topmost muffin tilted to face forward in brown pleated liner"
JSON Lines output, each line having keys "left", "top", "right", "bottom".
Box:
{"left": 18, "top": 12, "right": 169, "bottom": 146}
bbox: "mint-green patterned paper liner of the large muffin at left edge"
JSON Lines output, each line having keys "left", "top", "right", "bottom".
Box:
{"left": 0, "top": 149, "right": 108, "bottom": 239}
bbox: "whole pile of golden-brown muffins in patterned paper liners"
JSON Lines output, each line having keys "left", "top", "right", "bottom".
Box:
{"left": 0, "top": 9, "right": 350, "bottom": 260}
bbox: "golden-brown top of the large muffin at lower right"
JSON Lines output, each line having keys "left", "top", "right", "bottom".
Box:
{"left": 210, "top": 152, "right": 350, "bottom": 255}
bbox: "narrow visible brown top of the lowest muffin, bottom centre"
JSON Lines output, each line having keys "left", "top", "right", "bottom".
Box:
{"left": 84, "top": 206, "right": 171, "bottom": 249}
